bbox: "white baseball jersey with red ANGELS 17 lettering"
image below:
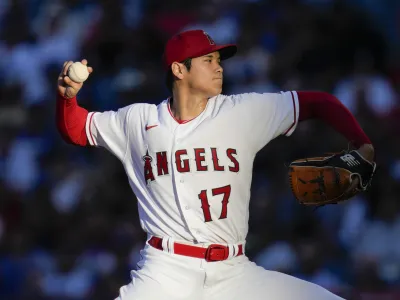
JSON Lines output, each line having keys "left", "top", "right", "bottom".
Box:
{"left": 86, "top": 92, "right": 299, "bottom": 244}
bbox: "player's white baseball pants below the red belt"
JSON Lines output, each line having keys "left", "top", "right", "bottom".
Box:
{"left": 116, "top": 245, "right": 342, "bottom": 300}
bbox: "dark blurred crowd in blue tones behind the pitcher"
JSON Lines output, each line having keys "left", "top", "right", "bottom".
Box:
{"left": 0, "top": 0, "right": 400, "bottom": 300}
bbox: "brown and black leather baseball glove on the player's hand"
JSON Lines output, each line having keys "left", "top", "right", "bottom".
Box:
{"left": 289, "top": 150, "right": 376, "bottom": 206}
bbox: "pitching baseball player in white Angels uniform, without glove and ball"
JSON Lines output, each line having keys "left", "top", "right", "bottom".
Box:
{"left": 57, "top": 30, "right": 374, "bottom": 300}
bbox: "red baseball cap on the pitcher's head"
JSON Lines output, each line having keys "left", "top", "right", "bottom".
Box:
{"left": 163, "top": 30, "right": 237, "bottom": 70}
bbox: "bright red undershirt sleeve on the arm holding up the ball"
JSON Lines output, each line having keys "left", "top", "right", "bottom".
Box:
{"left": 56, "top": 93, "right": 88, "bottom": 146}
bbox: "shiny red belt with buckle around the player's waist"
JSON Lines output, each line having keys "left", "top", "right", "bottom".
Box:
{"left": 148, "top": 236, "right": 243, "bottom": 262}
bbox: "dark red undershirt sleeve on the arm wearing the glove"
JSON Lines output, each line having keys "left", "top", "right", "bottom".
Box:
{"left": 297, "top": 92, "right": 371, "bottom": 148}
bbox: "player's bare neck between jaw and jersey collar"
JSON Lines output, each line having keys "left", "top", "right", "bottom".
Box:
{"left": 170, "top": 91, "right": 208, "bottom": 121}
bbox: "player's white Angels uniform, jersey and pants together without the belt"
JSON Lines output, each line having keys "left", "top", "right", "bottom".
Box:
{"left": 86, "top": 91, "right": 344, "bottom": 300}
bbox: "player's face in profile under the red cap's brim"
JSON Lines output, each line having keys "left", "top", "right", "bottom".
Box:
{"left": 187, "top": 52, "right": 223, "bottom": 98}
